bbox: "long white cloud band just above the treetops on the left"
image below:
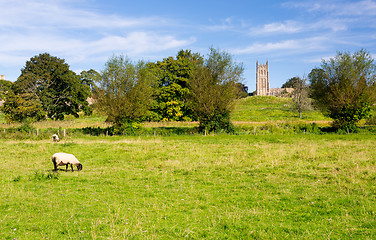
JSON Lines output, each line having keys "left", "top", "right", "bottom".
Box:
{"left": 0, "top": 32, "right": 196, "bottom": 65}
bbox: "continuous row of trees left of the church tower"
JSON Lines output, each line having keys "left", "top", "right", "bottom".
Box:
{"left": 0, "top": 48, "right": 248, "bottom": 131}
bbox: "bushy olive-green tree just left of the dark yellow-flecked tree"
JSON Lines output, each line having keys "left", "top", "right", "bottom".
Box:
{"left": 96, "top": 56, "right": 155, "bottom": 127}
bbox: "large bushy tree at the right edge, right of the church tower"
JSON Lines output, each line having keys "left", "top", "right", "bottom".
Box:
{"left": 308, "top": 50, "right": 376, "bottom": 132}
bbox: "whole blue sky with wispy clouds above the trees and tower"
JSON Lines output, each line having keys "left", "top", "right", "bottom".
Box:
{"left": 0, "top": 0, "right": 376, "bottom": 91}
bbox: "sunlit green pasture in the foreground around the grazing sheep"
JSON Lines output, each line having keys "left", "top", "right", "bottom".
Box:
{"left": 0, "top": 134, "right": 376, "bottom": 239}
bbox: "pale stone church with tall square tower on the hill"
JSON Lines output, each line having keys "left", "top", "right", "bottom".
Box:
{"left": 256, "top": 61, "right": 294, "bottom": 97}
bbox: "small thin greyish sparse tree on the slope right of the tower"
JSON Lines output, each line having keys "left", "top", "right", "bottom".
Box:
{"left": 292, "top": 77, "right": 311, "bottom": 118}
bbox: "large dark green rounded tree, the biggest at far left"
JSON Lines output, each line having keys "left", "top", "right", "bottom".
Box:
{"left": 13, "top": 53, "right": 90, "bottom": 120}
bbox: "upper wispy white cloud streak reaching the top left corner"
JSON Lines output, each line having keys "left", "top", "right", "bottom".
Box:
{"left": 0, "top": 0, "right": 163, "bottom": 30}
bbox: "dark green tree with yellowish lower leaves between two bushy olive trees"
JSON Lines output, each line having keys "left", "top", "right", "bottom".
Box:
{"left": 150, "top": 50, "right": 202, "bottom": 121}
